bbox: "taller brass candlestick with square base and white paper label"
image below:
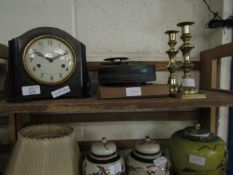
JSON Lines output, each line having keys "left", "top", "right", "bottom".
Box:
{"left": 177, "top": 22, "right": 206, "bottom": 99}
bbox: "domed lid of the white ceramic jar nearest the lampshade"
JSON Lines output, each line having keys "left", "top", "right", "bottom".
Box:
{"left": 91, "top": 137, "right": 116, "bottom": 156}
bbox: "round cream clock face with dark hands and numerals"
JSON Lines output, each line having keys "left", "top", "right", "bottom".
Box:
{"left": 23, "top": 35, "right": 77, "bottom": 85}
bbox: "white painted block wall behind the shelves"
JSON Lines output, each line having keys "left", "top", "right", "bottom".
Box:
{"left": 0, "top": 0, "right": 229, "bottom": 144}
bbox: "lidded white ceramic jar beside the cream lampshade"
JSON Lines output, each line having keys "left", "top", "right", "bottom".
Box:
{"left": 82, "top": 138, "right": 125, "bottom": 175}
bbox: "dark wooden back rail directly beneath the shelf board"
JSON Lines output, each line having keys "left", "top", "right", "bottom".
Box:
{"left": 30, "top": 110, "right": 200, "bottom": 124}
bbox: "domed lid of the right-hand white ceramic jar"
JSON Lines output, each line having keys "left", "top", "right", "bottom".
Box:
{"left": 135, "top": 136, "right": 160, "bottom": 155}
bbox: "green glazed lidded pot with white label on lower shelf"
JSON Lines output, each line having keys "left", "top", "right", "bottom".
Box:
{"left": 170, "top": 126, "right": 227, "bottom": 175}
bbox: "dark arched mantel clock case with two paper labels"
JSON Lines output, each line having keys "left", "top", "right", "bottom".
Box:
{"left": 7, "top": 27, "right": 90, "bottom": 101}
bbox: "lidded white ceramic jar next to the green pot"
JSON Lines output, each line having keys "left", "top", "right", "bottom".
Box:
{"left": 127, "top": 137, "right": 170, "bottom": 175}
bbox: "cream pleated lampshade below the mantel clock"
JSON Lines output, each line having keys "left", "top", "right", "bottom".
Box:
{"left": 5, "top": 125, "right": 80, "bottom": 175}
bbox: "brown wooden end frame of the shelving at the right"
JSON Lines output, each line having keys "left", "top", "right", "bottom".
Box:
{"left": 199, "top": 43, "right": 233, "bottom": 133}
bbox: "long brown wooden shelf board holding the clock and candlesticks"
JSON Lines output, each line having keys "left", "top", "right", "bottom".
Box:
{"left": 0, "top": 90, "right": 233, "bottom": 113}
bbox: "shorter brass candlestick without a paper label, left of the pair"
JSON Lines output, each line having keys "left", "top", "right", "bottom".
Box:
{"left": 165, "top": 30, "right": 179, "bottom": 96}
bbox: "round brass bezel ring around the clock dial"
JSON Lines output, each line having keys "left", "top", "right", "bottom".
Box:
{"left": 22, "top": 35, "right": 78, "bottom": 85}
